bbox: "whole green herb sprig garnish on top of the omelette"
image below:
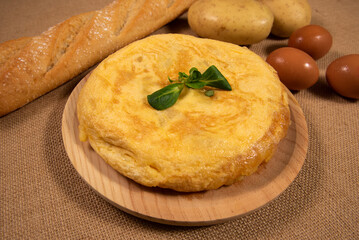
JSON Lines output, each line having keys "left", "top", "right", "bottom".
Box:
{"left": 147, "top": 65, "right": 232, "bottom": 110}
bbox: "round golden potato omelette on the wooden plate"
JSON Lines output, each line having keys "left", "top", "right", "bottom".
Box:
{"left": 77, "top": 34, "right": 290, "bottom": 192}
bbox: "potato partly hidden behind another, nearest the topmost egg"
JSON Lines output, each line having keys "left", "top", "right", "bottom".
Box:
{"left": 260, "top": 0, "right": 312, "bottom": 37}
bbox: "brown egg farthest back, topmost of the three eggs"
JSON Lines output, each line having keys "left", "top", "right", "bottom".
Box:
{"left": 288, "top": 25, "right": 333, "bottom": 59}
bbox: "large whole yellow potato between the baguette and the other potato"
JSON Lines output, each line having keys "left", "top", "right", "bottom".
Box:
{"left": 188, "top": 0, "right": 274, "bottom": 45}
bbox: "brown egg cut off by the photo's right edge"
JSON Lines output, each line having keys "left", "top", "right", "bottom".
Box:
{"left": 326, "top": 54, "right": 359, "bottom": 99}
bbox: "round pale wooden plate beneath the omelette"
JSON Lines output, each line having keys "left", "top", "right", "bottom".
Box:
{"left": 62, "top": 76, "right": 308, "bottom": 226}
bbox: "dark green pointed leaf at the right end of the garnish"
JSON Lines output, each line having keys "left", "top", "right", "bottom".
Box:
{"left": 199, "top": 65, "right": 232, "bottom": 91}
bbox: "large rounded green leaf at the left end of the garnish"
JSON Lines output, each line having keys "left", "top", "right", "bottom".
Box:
{"left": 147, "top": 83, "right": 184, "bottom": 110}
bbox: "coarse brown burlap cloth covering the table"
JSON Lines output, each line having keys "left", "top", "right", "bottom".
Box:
{"left": 0, "top": 0, "right": 359, "bottom": 239}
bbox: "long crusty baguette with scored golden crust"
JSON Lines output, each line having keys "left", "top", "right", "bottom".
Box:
{"left": 0, "top": 0, "right": 195, "bottom": 116}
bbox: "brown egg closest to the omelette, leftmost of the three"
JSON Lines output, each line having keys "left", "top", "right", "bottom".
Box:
{"left": 266, "top": 47, "right": 319, "bottom": 90}
